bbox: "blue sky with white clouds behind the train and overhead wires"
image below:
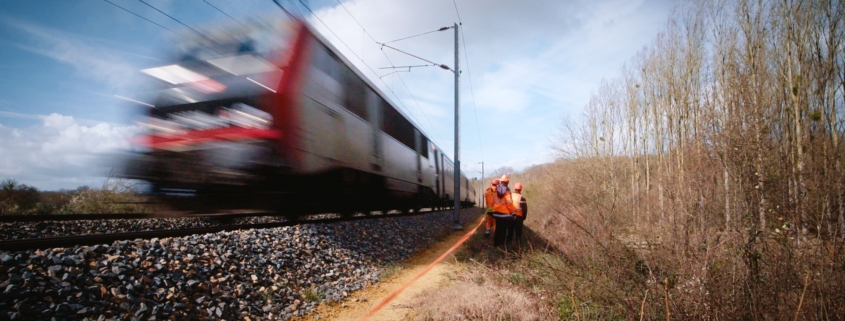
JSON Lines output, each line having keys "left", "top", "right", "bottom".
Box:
{"left": 0, "top": 0, "right": 674, "bottom": 190}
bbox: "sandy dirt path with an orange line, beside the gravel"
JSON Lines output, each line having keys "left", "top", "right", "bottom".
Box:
{"left": 308, "top": 216, "right": 483, "bottom": 321}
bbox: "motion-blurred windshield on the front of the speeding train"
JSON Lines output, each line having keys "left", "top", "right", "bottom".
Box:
{"left": 147, "top": 20, "right": 296, "bottom": 109}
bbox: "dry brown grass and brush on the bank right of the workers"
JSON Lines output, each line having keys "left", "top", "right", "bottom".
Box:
{"left": 415, "top": 154, "right": 845, "bottom": 320}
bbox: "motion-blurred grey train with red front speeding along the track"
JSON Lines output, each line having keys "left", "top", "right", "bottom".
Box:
{"left": 122, "top": 15, "right": 476, "bottom": 215}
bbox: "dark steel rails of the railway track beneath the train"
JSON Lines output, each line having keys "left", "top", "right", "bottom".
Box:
{"left": 0, "top": 210, "right": 452, "bottom": 251}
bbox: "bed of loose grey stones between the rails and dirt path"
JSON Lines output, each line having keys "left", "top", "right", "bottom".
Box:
{"left": 0, "top": 209, "right": 480, "bottom": 320}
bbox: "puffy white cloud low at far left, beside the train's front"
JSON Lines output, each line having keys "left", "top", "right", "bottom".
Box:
{"left": 0, "top": 113, "right": 138, "bottom": 190}
